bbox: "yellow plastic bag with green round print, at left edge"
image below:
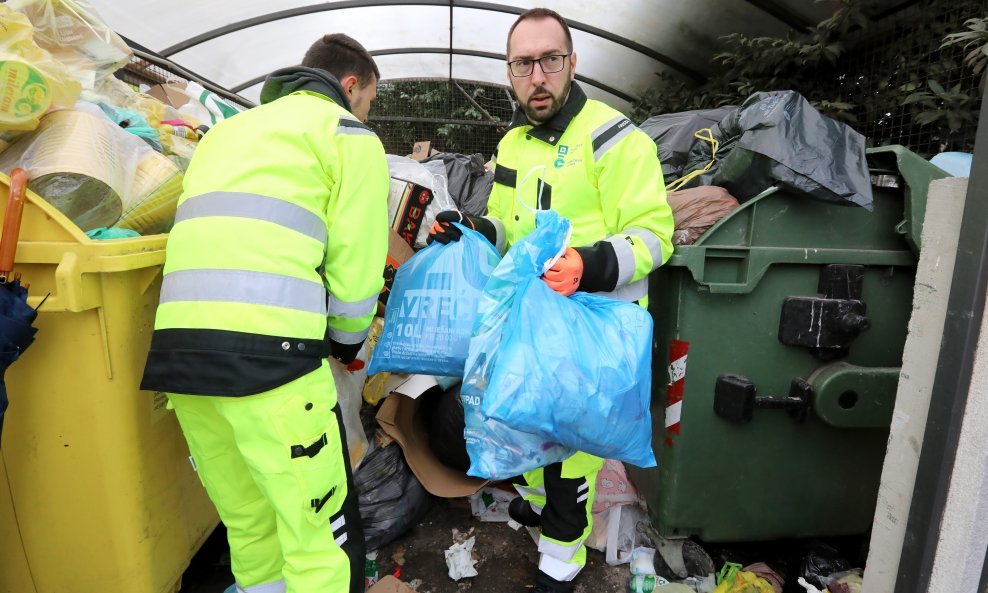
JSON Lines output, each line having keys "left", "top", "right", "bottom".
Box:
{"left": 0, "top": 4, "right": 80, "bottom": 133}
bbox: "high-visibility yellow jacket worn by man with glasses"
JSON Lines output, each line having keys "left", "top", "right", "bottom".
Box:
{"left": 487, "top": 83, "right": 675, "bottom": 303}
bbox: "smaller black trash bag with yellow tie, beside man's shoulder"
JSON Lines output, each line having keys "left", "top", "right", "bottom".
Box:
{"left": 639, "top": 107, "right": 737, "bottom": 185}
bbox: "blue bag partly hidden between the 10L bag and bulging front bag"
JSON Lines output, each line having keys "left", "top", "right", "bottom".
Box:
{"left": 460, "top": 211, "right": 575, "bottom": 480}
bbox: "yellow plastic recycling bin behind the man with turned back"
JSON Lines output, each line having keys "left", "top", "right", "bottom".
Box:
{"left": 0, "top": 175, "right": 218, "bottom": 593}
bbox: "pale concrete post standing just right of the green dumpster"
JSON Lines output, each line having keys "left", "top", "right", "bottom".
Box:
{"left": 863, "top": 177, "right": 964, "bottom": 593}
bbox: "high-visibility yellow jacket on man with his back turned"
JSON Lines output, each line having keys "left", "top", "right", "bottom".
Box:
{"left": 142, "top": 68, "right": 389, "bottom": 395}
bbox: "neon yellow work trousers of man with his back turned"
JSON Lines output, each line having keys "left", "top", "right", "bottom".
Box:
{"left": 168, "top": 361, "right": 364, "bottom": 593}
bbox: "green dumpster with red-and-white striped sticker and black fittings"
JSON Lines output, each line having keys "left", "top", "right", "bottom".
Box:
{"left": 629, "top": 147, "right": 946, "bottom": 542}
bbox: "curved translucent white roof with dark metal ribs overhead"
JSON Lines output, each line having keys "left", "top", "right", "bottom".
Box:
{"left": 91, "top": 0, "right": 916, "bottom": 110}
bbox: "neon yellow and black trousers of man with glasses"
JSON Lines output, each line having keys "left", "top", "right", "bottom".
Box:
{"left": 515, "top": 453, "right": 604, "bottom": 582}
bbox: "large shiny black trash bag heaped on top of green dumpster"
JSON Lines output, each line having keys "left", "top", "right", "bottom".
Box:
{"left": 683, "top": 91, "right": 872, "bottom": 211}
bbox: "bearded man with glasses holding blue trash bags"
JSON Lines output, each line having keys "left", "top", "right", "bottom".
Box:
{"left": 431, "top": 8, "right": 674, "bottom": 593}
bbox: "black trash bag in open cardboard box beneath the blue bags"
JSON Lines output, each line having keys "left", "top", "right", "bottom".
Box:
{"left": 419, "top": 384, "right": 470, "bottom": 474}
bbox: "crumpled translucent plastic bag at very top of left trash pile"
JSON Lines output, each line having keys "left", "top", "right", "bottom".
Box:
{"left": 7, "top": 0, "right": 133, "bottom": 89}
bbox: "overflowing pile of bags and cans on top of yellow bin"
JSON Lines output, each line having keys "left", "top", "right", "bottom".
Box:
{"left": 0, "top": 0, "right": 243, "bottom": 239}
